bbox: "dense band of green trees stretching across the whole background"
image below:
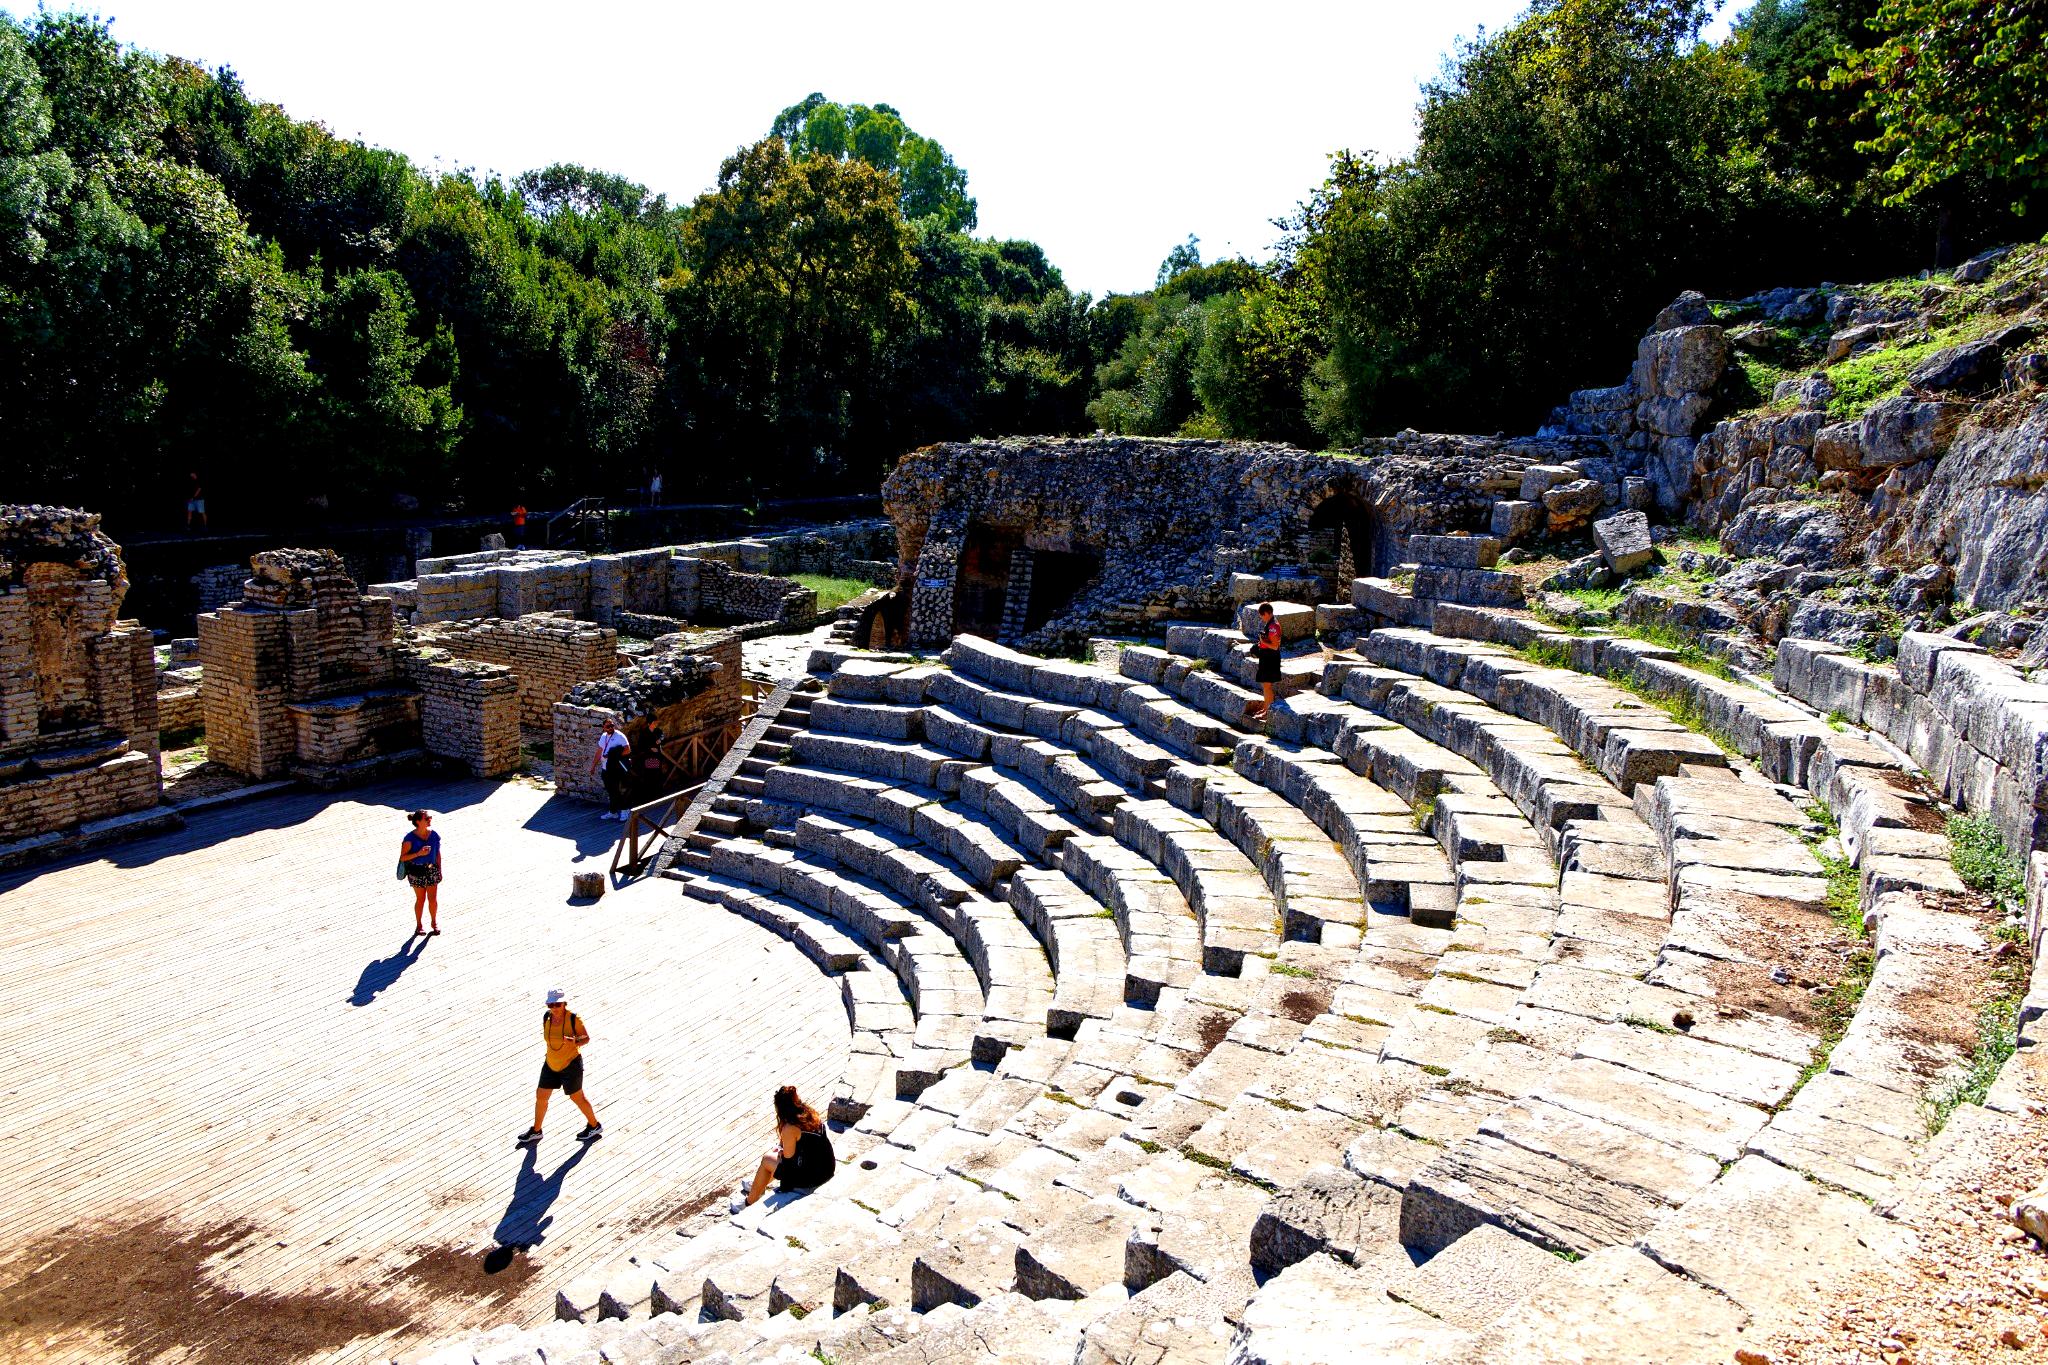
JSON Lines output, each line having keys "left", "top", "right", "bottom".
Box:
{"left": 0, "top": 0, "right": 2048, "bottom": 526}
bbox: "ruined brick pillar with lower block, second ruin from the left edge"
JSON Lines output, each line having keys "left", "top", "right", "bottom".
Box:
{"left": 199, "top": 551, "right": 518, "bottom": 788}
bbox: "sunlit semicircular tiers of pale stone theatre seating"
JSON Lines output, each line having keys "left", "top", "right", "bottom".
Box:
{"left": 403, "top": 605, "right": 2031, "bottom": 1361}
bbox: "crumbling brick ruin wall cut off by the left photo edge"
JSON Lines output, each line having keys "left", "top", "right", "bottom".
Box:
{"left": 0, "top": 505, "right": 162, "bottom": 845}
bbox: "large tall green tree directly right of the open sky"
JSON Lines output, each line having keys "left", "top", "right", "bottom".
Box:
{"left": 1292, "top": 0, "right": 1757, "bottom": 440}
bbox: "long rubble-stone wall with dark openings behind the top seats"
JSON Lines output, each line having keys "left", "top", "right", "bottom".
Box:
{"left": 883, "top": 432, "right": 1622, "bottom": 649}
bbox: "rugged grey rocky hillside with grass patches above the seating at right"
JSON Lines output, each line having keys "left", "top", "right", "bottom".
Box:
{"left": 1518, "top": 244, "right": 2048, "bottom": 679}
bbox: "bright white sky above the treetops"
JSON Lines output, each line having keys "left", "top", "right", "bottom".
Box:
{"left": 59, "top": 0, "right": 1728, "bottom": 295}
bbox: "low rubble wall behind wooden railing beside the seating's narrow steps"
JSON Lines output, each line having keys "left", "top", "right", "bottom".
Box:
{"left": 553, "top": 632, "right": 741, "bottom": 802}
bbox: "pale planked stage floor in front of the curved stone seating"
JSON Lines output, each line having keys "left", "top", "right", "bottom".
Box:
{"left": 0, "top": 782, "right": 850, "bottom": 1363}
